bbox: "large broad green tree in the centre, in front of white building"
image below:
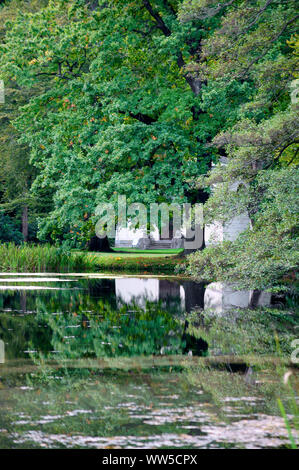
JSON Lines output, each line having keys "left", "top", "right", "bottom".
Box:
{"left": 1, "top": 0, "right": 233, "bottom": 248}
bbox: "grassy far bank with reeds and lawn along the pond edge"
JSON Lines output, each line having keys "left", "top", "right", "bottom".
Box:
{"left": 0, "top": 243, "right": 181, "bottom": 274}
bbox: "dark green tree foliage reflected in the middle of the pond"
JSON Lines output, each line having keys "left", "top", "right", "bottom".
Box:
{"left": 38, "top": 300, "right": 184, "bottom": 360}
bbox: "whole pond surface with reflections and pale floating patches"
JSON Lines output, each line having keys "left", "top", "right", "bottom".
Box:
{"left": 0, "top": 274, "right": 298, "bottom": 448}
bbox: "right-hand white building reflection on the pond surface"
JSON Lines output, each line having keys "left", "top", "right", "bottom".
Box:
{"left": 204, "top": 282, "right": 271, "bottom": 314}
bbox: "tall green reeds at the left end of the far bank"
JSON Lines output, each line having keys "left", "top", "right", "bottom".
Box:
{"left": 0, "top": 243, "right": 96, "bottom": 273}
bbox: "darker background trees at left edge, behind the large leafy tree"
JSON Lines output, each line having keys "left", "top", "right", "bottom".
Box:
{"left": 0, "top": 0, "right": 50, "bottom": 241}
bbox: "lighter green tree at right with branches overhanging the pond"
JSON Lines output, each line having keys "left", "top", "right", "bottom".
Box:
{"left": 182, "top": 1, "right": 298, "bottom": 289}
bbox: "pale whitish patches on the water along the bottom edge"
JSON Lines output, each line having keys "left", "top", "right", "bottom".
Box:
{"left": 14, "top": 415, "right": 298, "bottom": 449}
